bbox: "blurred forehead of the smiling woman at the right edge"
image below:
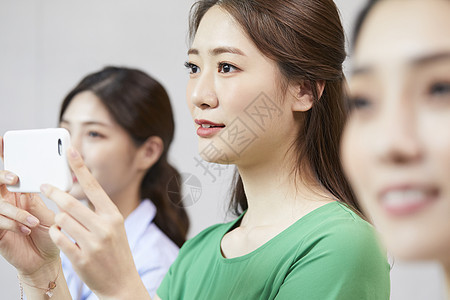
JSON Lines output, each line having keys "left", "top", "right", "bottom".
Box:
{"left": 353, "top": 0, "right": 450, "bottom": 66}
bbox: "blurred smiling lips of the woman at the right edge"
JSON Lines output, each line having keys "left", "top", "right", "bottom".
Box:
{"left": 379, "top": 186, "right": 439, "bottom": 216}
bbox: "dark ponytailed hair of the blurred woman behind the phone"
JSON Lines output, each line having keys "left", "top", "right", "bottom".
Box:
{"left": 59, "top": 67, "right": 189, "bottom": 247}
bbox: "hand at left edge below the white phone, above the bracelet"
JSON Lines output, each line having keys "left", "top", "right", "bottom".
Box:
{"left": 0, "top": 137, "right": 59, "bottom": 276}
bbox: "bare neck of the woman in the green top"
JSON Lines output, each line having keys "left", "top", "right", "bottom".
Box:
{"left": 238, "top": 146, "right": 332, "bottom": 226}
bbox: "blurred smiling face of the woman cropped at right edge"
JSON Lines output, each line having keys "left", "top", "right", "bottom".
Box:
{"left": 341, "top": 0, "right": 450, "bottom": 263}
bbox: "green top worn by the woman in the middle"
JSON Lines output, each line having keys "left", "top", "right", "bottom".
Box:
{"left": 157, "top": 201, "right": 390, "bottom": 300}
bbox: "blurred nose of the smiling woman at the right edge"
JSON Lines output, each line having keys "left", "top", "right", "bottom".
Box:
{"left": 375, "top": 103, "right": 423, "bottom": 164}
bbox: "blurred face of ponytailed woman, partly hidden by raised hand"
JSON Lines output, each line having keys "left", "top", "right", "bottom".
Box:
{"left": 60, "top": 91, "right": 138, "bottom": 200}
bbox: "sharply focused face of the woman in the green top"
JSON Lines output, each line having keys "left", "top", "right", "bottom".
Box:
{"left": 187, "top": 6, "right": 298, "bottom": 164}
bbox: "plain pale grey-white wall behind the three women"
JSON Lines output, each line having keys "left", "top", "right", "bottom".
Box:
{"left": 0, "top": 0, "right": 444, "bottom": 300}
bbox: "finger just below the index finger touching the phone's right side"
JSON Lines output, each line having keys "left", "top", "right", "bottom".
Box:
{"left": 41, "top": 184, "right": 99, "bottom": 231}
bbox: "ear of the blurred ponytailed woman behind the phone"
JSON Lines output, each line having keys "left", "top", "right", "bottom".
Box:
{"left": 135, "top": 136, "right": 164, "bottom": 171}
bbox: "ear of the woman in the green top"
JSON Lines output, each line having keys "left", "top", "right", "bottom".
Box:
{"left": 290, "top": 80, "right": 325, "bottom": 112}
